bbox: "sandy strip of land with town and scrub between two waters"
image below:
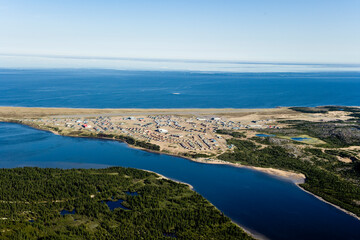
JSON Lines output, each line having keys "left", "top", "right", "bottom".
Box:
{"left": 0, "top": 106, "right": 360, "bottom": 220}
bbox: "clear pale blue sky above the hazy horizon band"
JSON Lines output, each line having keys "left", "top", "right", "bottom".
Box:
{"left": 0, "top": 0, "right": 360, "bottom": 65}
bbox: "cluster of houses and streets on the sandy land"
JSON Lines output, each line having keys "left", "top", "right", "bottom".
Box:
{"left": 22, "top": 115, "right": 279, "bottom": 154}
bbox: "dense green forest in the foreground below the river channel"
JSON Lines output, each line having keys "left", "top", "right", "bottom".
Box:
{"left": 0, "top": 167, "right": 252, "bottom": 239}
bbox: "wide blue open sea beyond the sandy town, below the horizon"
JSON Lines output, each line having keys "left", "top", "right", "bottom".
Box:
{"left": 0, "top": 69, "right": 360, "bottom": 108}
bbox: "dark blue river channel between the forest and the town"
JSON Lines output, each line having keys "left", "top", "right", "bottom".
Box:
{"left": 0, "top": 123, "right": 360, "bottom": 240}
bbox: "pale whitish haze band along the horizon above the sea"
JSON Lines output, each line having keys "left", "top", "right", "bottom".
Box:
{"left": 0, "top": 54, "right": 360, "bottom": 73}
